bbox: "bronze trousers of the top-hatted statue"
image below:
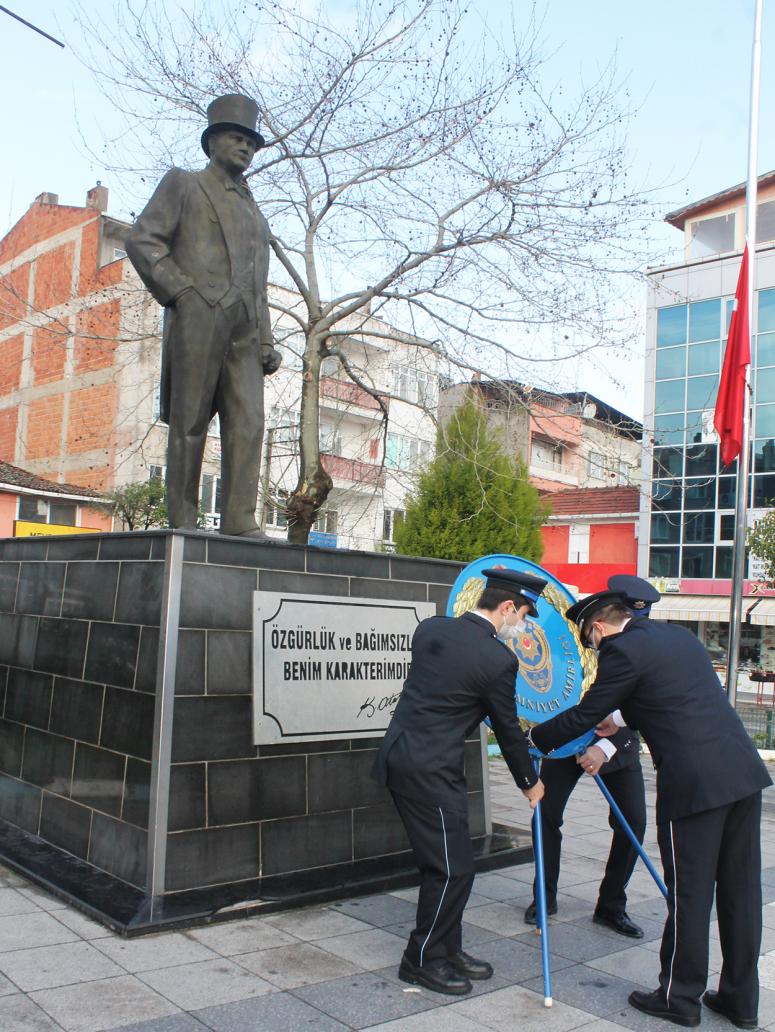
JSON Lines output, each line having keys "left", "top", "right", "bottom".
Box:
{"left": 165, "top": 290, "right": 264, "bottom": 534}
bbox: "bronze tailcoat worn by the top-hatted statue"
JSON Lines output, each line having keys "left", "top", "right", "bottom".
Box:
{"left": 126, "top": 166, "right": 271, "bottom": 421}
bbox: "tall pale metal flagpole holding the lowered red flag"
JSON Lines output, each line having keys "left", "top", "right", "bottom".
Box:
{"left": 726, "top": 0, "right": 763, "bottom": 706}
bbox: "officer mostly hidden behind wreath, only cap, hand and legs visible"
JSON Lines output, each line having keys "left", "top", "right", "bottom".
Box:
{"left": 524, "top": 574, "right": 660, "bottom": 939}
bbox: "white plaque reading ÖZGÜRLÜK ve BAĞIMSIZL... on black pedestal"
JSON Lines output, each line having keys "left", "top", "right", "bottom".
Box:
{"left": 253, "top": 591, "right": 435, "bottom": 745}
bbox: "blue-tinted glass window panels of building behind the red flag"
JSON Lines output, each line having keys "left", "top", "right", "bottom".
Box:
{"left": 642, "top": 288, "right": 775, "bottom": 580}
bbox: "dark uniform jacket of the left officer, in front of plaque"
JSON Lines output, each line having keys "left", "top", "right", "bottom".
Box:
{"left": 372, "top": 613, "right": 537, "bottom": 811}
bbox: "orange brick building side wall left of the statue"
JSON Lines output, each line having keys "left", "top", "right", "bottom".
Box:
{"left": 0, "top": 185, "right": 158, "bottom": 490}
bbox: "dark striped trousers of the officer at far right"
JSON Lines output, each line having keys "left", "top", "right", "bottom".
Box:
{"left": 656, "top": 792, "right": 762, "bottom": 1019}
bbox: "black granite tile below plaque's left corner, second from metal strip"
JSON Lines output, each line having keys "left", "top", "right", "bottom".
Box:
{"left": 207, "top": 756, "right": 306, "bottom": 826}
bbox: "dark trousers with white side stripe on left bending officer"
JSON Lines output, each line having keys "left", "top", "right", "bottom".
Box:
{"left": 391, "top": 793, "right": 475, "bottom": 967}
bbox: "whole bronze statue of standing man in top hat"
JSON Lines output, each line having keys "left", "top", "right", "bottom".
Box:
{"left": 126, "top": 94, "right": 281, "bottom": 537}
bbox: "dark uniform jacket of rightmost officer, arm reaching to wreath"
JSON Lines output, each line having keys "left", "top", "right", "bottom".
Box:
{"left": 531, "top": 619, "right": 771, "bottom": 823}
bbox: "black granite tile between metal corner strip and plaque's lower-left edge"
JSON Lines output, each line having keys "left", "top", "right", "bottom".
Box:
{"left": 172, "top": 696, "right": 256, "bottom": 764}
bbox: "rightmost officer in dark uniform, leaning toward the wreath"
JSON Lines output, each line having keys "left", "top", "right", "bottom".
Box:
{"left": 530, "top": 591, "right": 772, "bottom": 1029}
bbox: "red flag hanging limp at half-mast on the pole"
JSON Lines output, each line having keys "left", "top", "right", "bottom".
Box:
{"left": 713, "top": 244, "right": 751, "bottom": 465}
